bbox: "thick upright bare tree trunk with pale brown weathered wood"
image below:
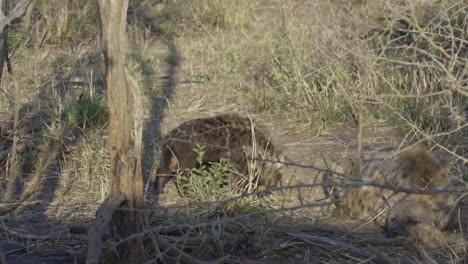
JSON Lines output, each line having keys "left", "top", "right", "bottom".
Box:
{"left": 99, "top": 0, "right": 143, "bottom": 263}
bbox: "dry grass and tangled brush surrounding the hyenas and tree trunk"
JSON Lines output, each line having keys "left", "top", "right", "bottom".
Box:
{"left": 0, "top": 0, "right": 468, "bottom": 263}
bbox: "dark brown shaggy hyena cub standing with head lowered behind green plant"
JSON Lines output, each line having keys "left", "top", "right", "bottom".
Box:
{"left": 155, "top": 114, "right": 285, "bottom": 194}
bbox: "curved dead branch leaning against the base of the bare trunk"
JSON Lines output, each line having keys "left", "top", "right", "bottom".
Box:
{"left": 86, "top": 193, "right": 127, "bottom": 264}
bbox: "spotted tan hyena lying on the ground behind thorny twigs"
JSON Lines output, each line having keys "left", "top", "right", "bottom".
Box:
{"left": 323, "top": 146, "right": 455, "bottom": 243}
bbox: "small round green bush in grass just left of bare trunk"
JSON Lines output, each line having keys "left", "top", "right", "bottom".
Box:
{"left": 67, "top": 93, "right": 109, "bottom": 129}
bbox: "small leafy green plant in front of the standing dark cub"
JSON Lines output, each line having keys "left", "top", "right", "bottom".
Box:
{"left": 176, "top": 144, "right": 232, "bottom": 201}
